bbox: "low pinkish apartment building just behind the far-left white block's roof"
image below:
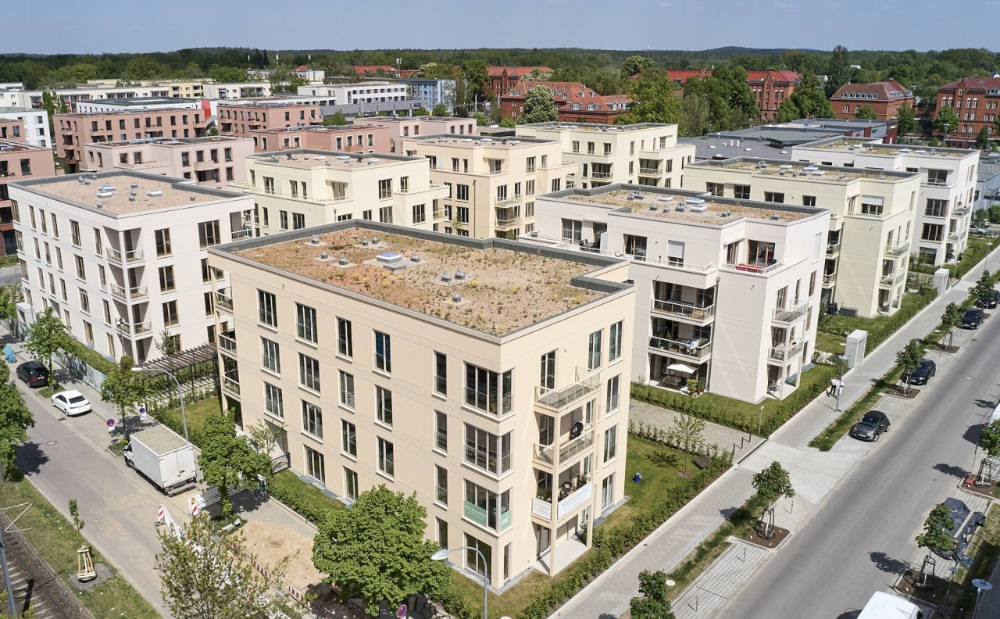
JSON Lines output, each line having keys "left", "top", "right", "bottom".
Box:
{"left": 80, "top": 135, "right": 253, "bottom": 189}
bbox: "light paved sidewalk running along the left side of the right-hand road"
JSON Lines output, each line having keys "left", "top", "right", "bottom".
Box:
{"left": 552, "top": 248, "right": 1000, "bottom": 617}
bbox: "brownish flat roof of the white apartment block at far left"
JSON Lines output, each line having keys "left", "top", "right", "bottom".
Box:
{"left": 11, "top": 169, "right": 244, "bottom": 216}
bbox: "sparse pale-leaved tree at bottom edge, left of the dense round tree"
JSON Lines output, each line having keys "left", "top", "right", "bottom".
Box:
{"left": 153, "top": 516, "right": 292, "bottom": 619}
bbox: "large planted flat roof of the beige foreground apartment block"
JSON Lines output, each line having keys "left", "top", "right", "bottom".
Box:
{"left": 225, "top": 221, "right": 630, "bottom": 336}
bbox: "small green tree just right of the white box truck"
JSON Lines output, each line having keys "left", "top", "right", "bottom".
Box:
{"left": 198, "top": 412, "right": 271, "bottom": 518}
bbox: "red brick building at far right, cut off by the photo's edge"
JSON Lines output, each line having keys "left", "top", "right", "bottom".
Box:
{"left": 934, "top": 77, "right": 1000, "bottom": 146}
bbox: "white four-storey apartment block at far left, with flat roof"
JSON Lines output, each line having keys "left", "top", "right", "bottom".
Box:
{"left": 10, "top": 170, "right": 253, "bottom": 363}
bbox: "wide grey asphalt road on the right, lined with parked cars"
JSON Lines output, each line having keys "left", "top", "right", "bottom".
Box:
{"left": 719, "top": 313, "right": 1000, "bottom": 619}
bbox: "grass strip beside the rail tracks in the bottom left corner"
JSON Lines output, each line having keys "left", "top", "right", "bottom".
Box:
{"left": 0, "top": 480, "right": 159, "bottom": 617}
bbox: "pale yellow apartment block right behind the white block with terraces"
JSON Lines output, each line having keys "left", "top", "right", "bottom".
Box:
{"left": 684, "top": 157, "right": 920, "bottom": 318}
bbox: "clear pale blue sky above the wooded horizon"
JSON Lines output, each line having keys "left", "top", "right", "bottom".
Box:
{"left": 0, "top": 0, "right": 1000, "bottom": 54}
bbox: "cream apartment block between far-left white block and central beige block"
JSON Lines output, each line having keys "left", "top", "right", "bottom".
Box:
{"left": 230, "top": 149, "right": 450, "bottom": 235}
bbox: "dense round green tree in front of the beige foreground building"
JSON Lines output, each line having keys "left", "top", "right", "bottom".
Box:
{"left": 313, "top": 485, "right": 451, "bottom": 615}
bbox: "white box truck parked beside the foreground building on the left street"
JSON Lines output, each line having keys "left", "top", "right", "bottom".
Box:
{"left": 123, "top": 424, "right": 198, "bottom": 495}
